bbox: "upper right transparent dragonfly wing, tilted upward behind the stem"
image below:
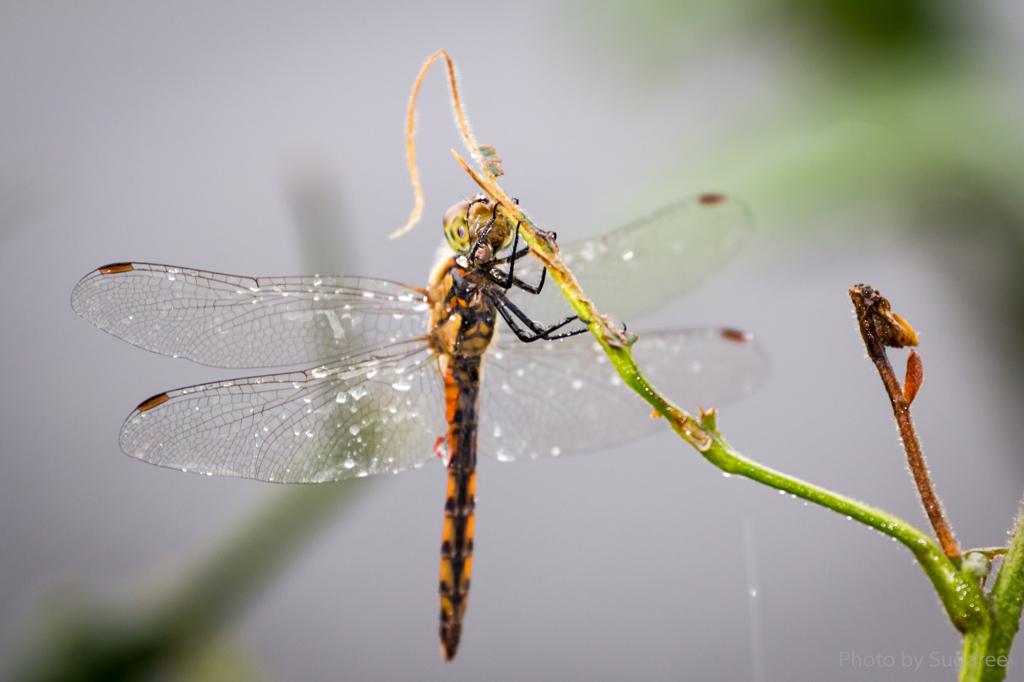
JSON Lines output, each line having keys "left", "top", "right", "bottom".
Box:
{"left": 509, "top": 195, "right": 752, "bottom": 324}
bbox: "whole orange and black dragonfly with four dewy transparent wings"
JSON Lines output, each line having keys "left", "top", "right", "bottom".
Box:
{"left": 72, "top": 188, "right": 767, "bottom": 659}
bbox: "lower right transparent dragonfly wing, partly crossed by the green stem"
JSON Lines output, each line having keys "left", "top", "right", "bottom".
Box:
{"left": 478, "top": 329, "right": 768, "bottom": 462}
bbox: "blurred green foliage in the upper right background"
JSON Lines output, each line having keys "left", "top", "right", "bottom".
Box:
{"left": 595, "top": 0, "right": 1024, "bottom": 360}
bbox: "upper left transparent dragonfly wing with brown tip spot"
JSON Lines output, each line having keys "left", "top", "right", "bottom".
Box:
{"left": 71, "top": 263, "right": 430, "bottom": 368}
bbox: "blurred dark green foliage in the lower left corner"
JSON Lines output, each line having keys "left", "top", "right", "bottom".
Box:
{"left": 8, "top": 479, "right": 367, "bottom": 682}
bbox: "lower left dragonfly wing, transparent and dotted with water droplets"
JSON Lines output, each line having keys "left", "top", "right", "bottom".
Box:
{"left": 121, "top": 342, "right": 447, "bottom": 483}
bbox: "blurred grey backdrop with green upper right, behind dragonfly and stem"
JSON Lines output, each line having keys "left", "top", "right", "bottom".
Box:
{"left": 0, "top": 0, "right": 1024, "bottom": 680}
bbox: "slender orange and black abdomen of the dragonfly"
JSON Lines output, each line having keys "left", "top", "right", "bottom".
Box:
{"left": 440, "top": 355, "right": 480, "bottom": 660}
